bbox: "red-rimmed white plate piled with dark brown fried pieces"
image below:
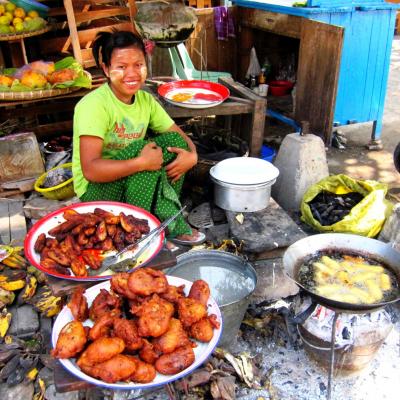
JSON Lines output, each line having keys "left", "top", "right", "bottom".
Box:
{"left": 24, "top": 201, "right": 165, "bottom": 281}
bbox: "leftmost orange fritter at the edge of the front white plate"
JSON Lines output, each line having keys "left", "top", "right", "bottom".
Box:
{"left": 51, "top": 321, "right": 87, "bottom": 358}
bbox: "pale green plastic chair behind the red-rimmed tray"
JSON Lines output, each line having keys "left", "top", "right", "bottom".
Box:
{"left": 168, "top": 43, "right": 232, "bottom": 82}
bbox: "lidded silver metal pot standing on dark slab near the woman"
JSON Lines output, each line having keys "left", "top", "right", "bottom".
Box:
{"left": 210, "top": 157, "right": 279, "bottom": 212}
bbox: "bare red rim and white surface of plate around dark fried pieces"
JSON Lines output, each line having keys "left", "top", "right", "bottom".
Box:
{"left": 24, "top": 201, "right": 165, "bottom": 281}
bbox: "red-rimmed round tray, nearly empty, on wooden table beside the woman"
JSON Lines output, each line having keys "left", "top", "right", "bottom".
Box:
{"left": 158, "top": 80, "right": 230, "bottom": 108}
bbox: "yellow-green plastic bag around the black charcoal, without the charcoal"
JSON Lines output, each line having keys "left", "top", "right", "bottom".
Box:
{"left": 300, "top": 174, "right": 392, "bottom": 237}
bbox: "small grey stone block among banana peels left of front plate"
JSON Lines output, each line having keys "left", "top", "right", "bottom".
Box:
{"left": 7, "top": 304, "right": 39, "bottom": 339}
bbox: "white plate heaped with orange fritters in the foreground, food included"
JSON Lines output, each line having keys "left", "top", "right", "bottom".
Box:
{"left": 51, "top": 267, "right": 222, "bottom": 389}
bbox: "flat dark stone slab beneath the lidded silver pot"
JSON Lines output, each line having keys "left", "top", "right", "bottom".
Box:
{"left": 226, "top": 198, "right": 306, "bottom": 253}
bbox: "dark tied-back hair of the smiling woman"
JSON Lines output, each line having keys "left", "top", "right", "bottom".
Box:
{"left": 92, "top": 31, "right": 146, "bottom": 68}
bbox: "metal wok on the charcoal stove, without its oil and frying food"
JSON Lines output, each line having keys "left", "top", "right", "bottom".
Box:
{"left": 283, "top": 233, "right": 400, "bottom": 312}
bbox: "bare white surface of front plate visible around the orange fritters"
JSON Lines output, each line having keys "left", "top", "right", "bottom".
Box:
{"left": 51, "top": 275, "right": 223, "bottom": 389}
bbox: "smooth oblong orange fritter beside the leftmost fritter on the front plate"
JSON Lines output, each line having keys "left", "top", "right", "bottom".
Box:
{"left": 76, "top": 337, "right": 125, "bottom": 368}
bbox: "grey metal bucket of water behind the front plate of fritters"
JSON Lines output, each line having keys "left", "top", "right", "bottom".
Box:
{"left": 168, "top": 250, "right": 257, "bottom": 348}
